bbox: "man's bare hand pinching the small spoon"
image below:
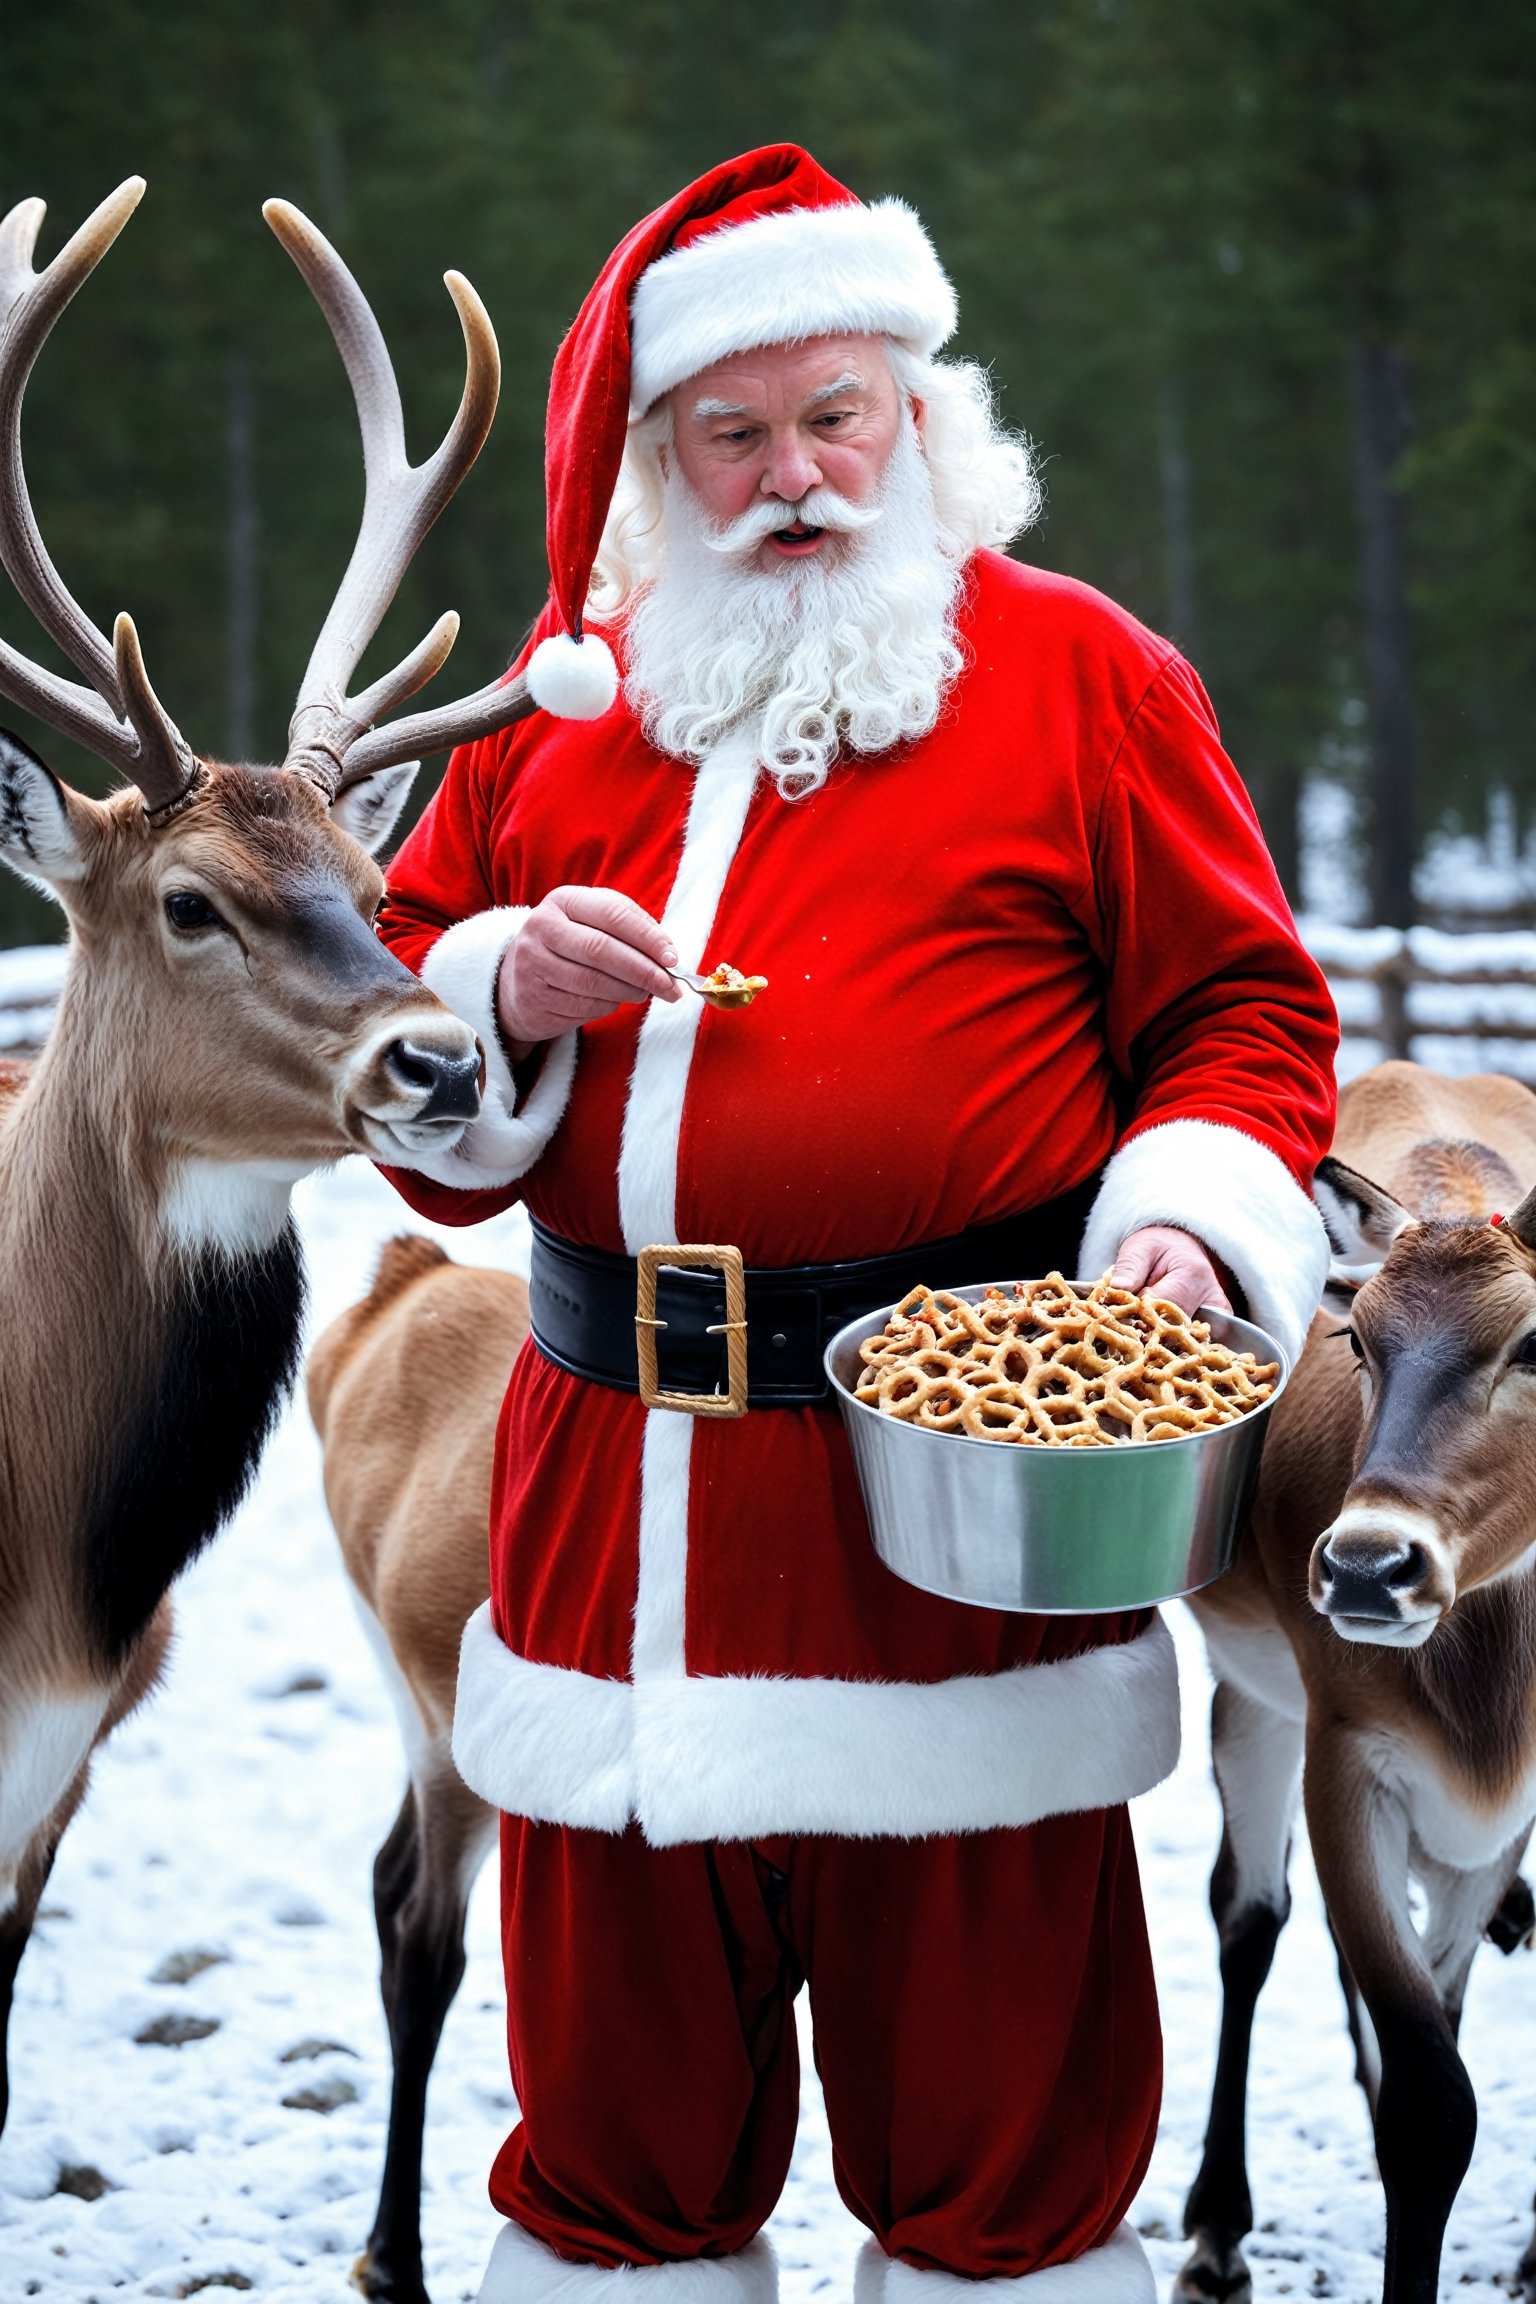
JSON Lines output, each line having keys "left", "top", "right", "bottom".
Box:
{"left": 495, "top": 887, "right": 682, "bottom": 1062}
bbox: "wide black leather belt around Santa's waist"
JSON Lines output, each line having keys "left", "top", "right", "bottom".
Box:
{"left": 527, "top": 1175, "right": 1098, "bottom": 1415}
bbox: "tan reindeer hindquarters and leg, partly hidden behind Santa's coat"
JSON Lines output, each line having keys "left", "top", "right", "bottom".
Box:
{"left": 306, "top": 1235, "right": 527, "bottom": 2304}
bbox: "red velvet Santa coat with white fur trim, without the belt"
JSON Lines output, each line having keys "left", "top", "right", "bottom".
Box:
{"left": 382, "top": 553, "right": 1336, "bottom": 1841}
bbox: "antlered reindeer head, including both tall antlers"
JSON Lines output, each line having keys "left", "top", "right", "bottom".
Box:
{"left": 0, "top": 177, "right": 545, "bottom": 1242}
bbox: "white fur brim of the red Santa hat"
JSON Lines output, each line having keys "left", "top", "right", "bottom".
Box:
{"left": 629, "top": 200, "right": 958, "bottom": 415}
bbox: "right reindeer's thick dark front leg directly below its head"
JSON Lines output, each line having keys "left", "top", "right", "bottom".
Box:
{"left": 1306, "top": 1723, "right": 1473, "bottom": 2304}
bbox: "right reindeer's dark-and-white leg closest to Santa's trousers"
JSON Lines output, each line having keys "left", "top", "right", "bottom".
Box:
{"left": 1174, "top": 1680, "right": 1301, "bottom": 2304}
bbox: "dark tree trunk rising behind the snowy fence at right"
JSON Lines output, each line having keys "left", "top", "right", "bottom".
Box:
{"left": 1349, "top": 336, "right": 1419, "bottom": 929}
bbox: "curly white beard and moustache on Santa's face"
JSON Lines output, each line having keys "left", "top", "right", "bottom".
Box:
{"left": 624, "top": 419, "right": 963, "bottom": 799}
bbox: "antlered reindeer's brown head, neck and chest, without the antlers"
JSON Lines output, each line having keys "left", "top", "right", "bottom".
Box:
{"left": 0, "top": 760, "right": 477, "bottom": 2117}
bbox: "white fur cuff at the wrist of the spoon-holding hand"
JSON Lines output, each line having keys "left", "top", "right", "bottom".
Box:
{"left": 398, "top": 905, "right": 576, "bottom": 1191}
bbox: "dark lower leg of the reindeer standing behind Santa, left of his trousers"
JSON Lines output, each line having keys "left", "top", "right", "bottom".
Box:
{"left": 352, "top": 1751, "right": 495, "bottom": 2304}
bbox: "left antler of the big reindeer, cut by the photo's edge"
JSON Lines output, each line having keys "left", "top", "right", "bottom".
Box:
{"left": 0, "top": 175, "right": 203, "bottom": 816}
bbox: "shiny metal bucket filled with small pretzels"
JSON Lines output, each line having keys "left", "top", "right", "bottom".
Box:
{"left": 827, "top": 1272, "right": 1290, "bottom": 1615}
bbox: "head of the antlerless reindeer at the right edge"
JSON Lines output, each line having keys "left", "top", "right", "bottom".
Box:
{"left": 1310, "top": 1159, "right": 1536, "bottom": 1647}
